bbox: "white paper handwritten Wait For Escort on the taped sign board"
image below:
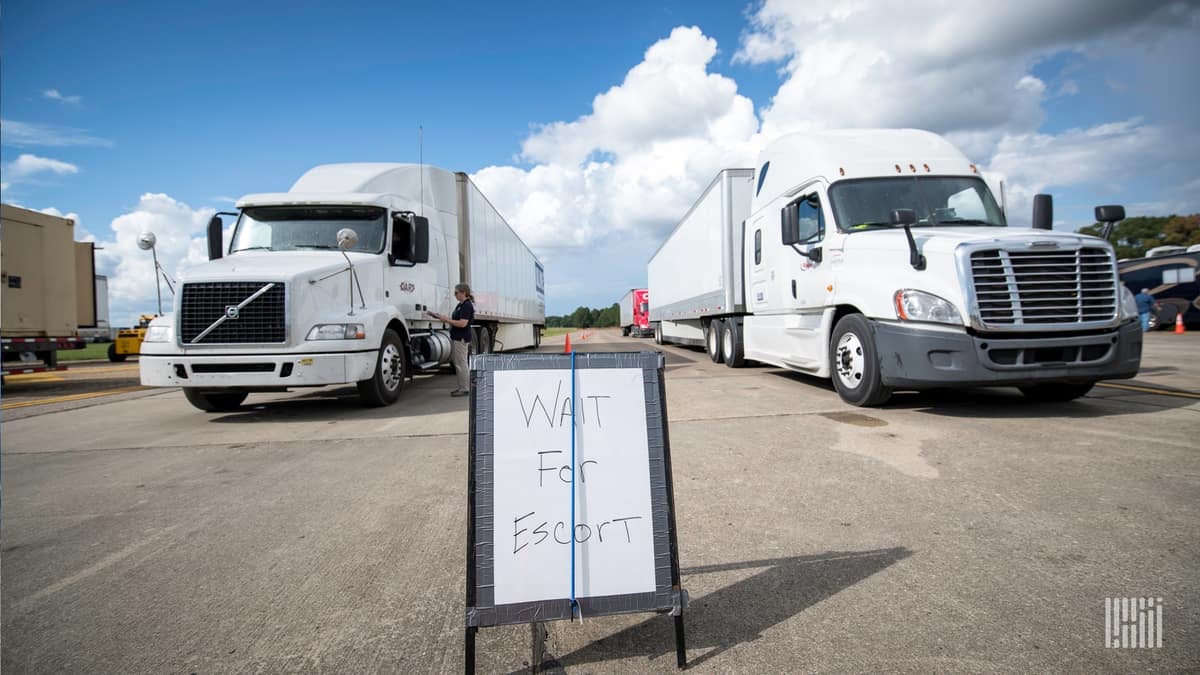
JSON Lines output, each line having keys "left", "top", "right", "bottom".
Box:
{"left": 493, "top": 369, "right": 655, "bottom": 605}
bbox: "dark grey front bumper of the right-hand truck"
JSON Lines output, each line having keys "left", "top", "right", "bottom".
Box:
{"left": 874, "top": 322, "right": 1142, "bottom": 389}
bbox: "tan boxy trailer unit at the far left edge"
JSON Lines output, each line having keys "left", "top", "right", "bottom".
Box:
{"left": 0, "top": 204, "right": 96, "bottom": 375}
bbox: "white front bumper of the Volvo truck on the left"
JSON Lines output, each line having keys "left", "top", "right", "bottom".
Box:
{"left": 138, "top": 350, "right": 379, "bottom": 390}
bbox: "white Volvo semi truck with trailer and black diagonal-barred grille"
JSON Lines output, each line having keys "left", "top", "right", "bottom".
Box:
{"left": 140, "top": 163, "right": 546, "bottom": 412}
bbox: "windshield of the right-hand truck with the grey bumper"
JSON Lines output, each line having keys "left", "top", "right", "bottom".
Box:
{"left": 829, "top": 175, "right": 1004, "bottom": 232}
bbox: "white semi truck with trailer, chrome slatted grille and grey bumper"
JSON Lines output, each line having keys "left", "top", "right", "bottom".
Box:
{"left": 647, "top": 130, "right": 1141, "bottom": 406}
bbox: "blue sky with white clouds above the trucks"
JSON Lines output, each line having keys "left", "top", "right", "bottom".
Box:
{"left": 0, "top": 0, "right": 1200, "bottom": 323}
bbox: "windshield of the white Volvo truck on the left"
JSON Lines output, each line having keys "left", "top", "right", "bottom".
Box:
{"left": 229, "top": 207, "right": 388, "bottom": 253}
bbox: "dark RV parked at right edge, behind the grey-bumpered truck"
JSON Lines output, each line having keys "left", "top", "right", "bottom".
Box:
{"left": 1118, "top": 246, "right": 1200, "bottom": 330}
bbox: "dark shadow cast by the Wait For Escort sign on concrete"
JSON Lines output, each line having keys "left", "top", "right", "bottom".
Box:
{"left": 542, "top": 546, "right": 912, "bottom": 669}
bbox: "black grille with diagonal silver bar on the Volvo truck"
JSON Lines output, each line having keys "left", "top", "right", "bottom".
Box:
{"left": 179, "top": 281, "right": 287, "bottom": 345}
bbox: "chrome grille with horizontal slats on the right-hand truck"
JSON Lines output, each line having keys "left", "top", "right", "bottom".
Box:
{"left": 971, "top": 247, "right": 1120, "bottom": 327}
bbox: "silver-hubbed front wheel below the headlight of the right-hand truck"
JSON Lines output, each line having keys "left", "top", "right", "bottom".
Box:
{"left": 829, "top": 313, "right": 892, "bottom": 406}
